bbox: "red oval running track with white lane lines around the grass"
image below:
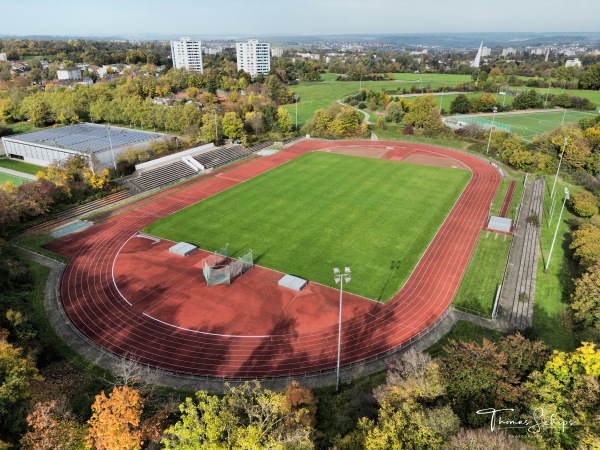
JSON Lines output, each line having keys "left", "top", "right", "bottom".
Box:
{"left": 47, "top": 140, "right": 500, "bottom": 378}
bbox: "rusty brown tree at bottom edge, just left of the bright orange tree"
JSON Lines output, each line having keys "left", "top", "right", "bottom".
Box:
{"left": 21, "top": 400, "right": 86, "bottom": 450}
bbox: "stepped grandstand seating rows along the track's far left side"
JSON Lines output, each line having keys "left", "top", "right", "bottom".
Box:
{"left": 127, "top": 141, "right": 273, "bottom": 192}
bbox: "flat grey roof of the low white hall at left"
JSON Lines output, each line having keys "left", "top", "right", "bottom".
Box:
{"left": 10, "top": 123, "right": 162, "bottom": 154}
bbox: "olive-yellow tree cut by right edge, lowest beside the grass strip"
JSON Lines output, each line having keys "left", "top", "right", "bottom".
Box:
{"left": 571, "top": 261, "right": 600, "bottom": 331}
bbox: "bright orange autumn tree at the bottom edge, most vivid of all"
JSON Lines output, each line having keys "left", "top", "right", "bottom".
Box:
{"left": 87, "top": 386, "right": 143, "bottom": 450}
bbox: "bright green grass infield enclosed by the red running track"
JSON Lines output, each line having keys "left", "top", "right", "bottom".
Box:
{"left": 144, "top": 152, "right": 471, "bottom": 301}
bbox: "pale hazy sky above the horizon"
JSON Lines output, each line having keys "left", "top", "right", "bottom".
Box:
{"left": 0, "top": 0, "right": 600, "bottom": 37}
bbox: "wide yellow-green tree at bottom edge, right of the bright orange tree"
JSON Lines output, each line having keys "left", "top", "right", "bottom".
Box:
{"left": 162, "top": 382, "right": 313, "bottom": 450}
